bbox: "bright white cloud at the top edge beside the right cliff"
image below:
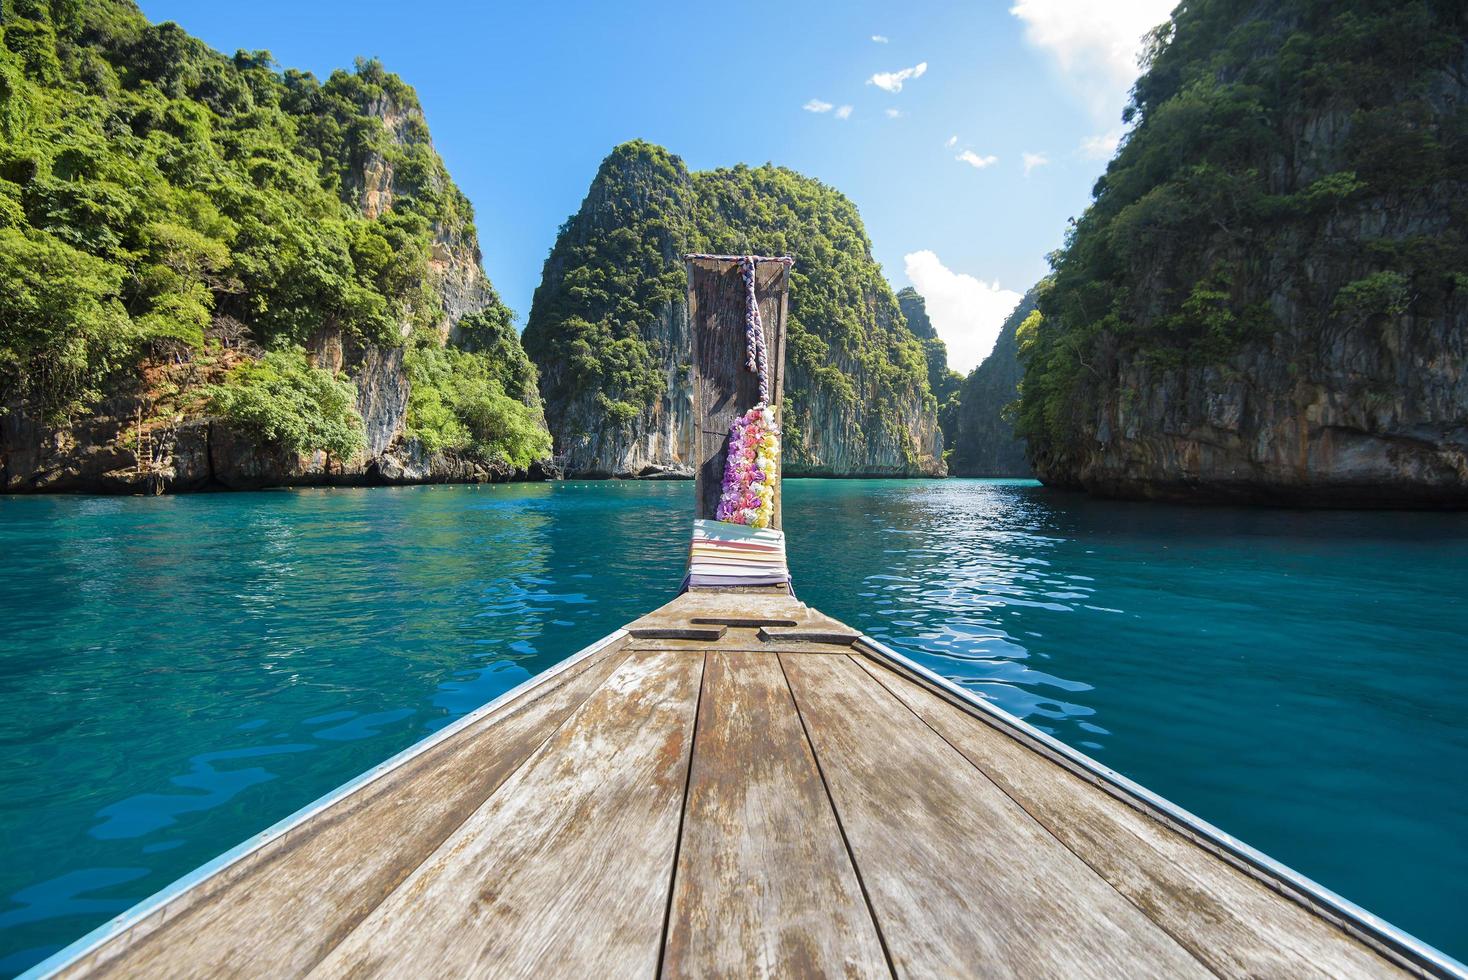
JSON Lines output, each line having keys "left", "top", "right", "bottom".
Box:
{"left": 1010, "top": 0, "right": 1176, "bottom": 120}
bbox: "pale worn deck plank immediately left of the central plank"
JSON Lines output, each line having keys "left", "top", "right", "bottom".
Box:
{"left": 313, "top": 653, "right": 703, "bottom": 977}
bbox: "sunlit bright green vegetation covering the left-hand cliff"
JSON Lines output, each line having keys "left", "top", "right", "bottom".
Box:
{"left": 0, "top": 0, "right": 549, "bottom": 469}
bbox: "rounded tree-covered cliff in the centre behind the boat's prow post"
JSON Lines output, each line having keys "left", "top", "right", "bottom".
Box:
{"left": 524, "top": 142, "right": 942, "bottom": 477}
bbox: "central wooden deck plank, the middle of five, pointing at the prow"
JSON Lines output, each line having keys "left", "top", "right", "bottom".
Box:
{"left": 664, "top": 653, "right": 890, "bottom": 977}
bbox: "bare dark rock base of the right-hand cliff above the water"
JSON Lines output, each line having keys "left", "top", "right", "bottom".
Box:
{"left": 1068, "top": 303, "right": 1468, "bottom": 508}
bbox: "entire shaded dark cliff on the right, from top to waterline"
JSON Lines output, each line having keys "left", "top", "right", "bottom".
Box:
{"left": 1020, "top": 0, "right": 1468, "bottom": 508}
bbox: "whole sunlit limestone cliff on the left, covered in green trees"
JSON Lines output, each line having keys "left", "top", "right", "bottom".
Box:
{"left": 0, "top": 0, "right": 549, "bottom": 493}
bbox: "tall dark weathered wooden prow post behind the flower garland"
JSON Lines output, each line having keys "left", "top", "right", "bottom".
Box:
{"left": 688, "top": 258, "right": 790, "bottom": 528}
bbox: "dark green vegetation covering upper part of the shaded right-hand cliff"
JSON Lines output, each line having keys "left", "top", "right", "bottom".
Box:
{"left": 1019, "top": 0, "right": 1468, "bottom": 480}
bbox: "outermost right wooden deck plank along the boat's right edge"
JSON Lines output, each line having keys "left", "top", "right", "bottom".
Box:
{"left": 859, "top": 657, "right": 1402, "bottom": 977}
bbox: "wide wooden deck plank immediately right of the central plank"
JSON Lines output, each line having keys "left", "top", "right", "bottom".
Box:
{"left": 781, "top": 654, "right": 1211, "bottom": 977}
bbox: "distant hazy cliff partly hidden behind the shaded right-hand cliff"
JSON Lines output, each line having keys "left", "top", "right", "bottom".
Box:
{"left": 948, "top": 289, "right": 1035, "bottom": 477}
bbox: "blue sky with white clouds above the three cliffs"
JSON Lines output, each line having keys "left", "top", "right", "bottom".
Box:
{"left": 141, "top": 0, "right": 1170, "bottom": 371}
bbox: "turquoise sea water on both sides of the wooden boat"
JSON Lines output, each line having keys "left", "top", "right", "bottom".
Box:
{"left": 0, "top": 480, "right": 1468, "bottom": 973}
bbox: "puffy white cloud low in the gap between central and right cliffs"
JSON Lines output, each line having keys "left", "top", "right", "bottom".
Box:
{"left": 903, "top": 249, "right": 1020, "bottom": 374}
